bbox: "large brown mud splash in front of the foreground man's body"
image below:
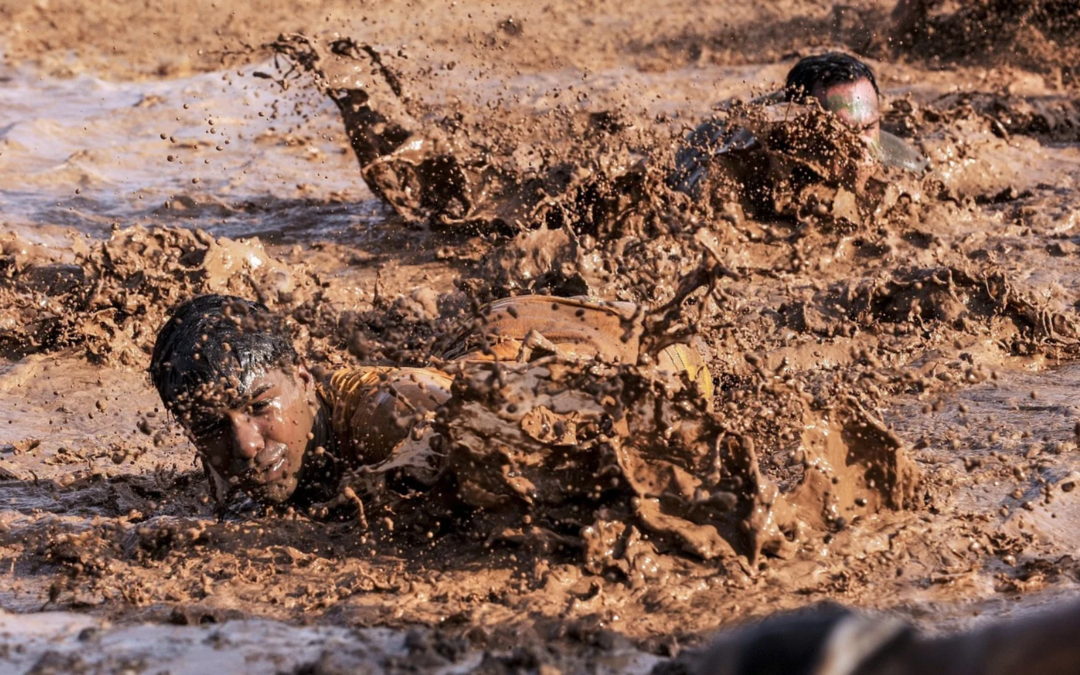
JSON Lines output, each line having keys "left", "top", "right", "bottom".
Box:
{"left": 362, "top": 359, "right": 918, "bottom": 570}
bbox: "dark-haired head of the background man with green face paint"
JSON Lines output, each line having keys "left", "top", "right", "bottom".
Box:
{"left": 784, "top": 52, "right": 881, "bottom": 144}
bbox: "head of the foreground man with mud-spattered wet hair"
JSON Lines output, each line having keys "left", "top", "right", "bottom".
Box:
{"left": 149, "top": 295, "right": 318, "bottom": 502}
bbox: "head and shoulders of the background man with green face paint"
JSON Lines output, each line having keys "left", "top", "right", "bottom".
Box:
{"left": 669, "top": 52, "right": 927, "bottom": 208}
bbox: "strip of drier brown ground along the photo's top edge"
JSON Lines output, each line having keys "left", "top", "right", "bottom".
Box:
{"left": 10, "top": 0, "right": 1080, "bottom": 80}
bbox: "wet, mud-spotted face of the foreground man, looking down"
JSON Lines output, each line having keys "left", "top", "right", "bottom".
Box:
{"left": 180, "top": 366, "right": 318, "bottom": 503}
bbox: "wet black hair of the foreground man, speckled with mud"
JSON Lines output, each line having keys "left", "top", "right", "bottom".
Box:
{"left": 149, "top": 295, "right": 298, "bottom": 411}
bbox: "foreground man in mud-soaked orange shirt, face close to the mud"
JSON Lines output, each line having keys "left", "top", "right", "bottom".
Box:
{"left": 149, "top": 295, "right": 713, "bottom": 509}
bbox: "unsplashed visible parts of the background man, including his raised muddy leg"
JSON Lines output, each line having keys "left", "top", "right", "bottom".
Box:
{"left": 273, "top": 36, "right": 926, "bottom": 232}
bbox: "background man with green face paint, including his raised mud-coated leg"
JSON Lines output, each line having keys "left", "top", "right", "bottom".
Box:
{"left": 271, "top": 36, "right": 926, "bottom": 233}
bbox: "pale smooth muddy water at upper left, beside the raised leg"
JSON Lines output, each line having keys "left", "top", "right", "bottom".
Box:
{"left": 0, "top": 52, "right": 374, "bottom": 243}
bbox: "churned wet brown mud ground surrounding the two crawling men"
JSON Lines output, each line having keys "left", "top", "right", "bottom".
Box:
{"left": 0, "top": 1, "right": 1080, "bottom": 675}
